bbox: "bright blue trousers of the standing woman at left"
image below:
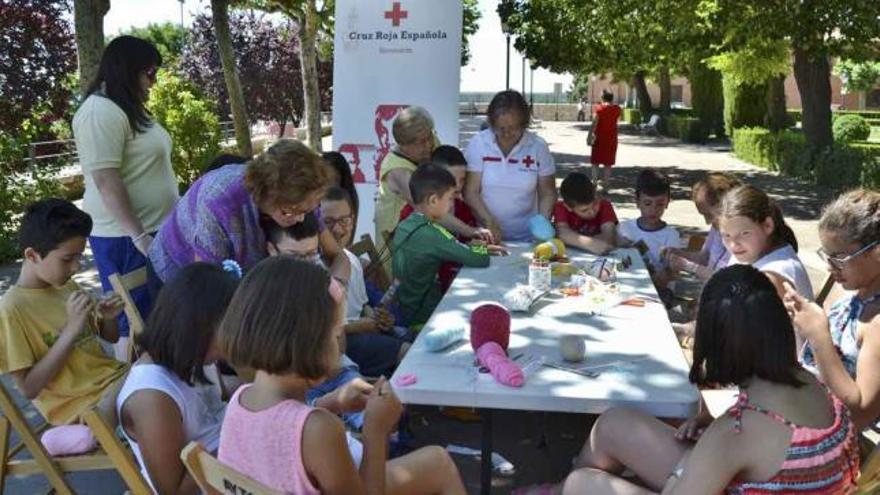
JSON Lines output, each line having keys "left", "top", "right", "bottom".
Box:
{"left": 89, "top": 236, "right": 161, "bottom": 337}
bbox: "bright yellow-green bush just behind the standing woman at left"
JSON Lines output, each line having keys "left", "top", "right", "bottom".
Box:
{"left": 148, "top": 70, "right": 221, "bottom": 187}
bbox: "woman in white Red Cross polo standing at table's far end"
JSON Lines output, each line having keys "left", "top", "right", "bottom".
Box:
{"left": 464, "top": 90, "right": 556, "bottom": 242}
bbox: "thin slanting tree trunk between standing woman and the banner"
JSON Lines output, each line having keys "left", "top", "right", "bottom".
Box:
{"left": 211, "top": 0, "right": 254, "bottom": 157}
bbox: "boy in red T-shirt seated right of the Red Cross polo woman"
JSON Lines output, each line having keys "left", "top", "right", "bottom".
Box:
{"left": 553, "top": 172, "right": 617, "bottom": 255}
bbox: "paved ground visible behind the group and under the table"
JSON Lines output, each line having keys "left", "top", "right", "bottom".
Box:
{"left": 0, "top": 118, "right": 829, "bottom": 494}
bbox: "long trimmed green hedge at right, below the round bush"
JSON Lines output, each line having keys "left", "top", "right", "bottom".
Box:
{"left": 733, "top": 127, "right": 880, "bottom": 190}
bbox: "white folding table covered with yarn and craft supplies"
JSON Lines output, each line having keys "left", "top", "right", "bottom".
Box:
{"left": 391, "top": 244, "right": 700, "bottom": 493}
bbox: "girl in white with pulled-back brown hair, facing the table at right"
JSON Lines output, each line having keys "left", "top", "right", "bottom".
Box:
{"left": 718, "top": 185, "right": 813, "bottom": 300}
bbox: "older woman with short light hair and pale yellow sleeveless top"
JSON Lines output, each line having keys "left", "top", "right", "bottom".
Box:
{"left": 375, "top": 106, "right": 492, "bottom": 273}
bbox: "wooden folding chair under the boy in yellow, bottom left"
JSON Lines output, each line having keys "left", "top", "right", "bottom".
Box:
{"left": 0, "top": 384, "right": 152, "bottom": 495}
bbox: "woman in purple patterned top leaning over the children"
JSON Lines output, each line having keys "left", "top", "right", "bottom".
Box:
{"left": 150, "top": 139, "right": 350, "bottom": 282}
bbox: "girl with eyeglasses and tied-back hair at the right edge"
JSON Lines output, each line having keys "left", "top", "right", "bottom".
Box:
{"left": 784, "top": 189, "right": 880, "bottom": 429}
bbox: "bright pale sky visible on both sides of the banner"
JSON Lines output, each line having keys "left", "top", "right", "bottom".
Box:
{"left": 104, "top": 0, "right": 571, "bottom": 93}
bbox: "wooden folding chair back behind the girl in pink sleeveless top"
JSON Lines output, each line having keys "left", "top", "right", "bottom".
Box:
{"left": 180, "top": 442, "right": 281, "bottom": 495}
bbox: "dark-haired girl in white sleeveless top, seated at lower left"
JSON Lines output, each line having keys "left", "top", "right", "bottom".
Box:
{"left": 116, "top": 263, "right": 238, "bottom": 494}
